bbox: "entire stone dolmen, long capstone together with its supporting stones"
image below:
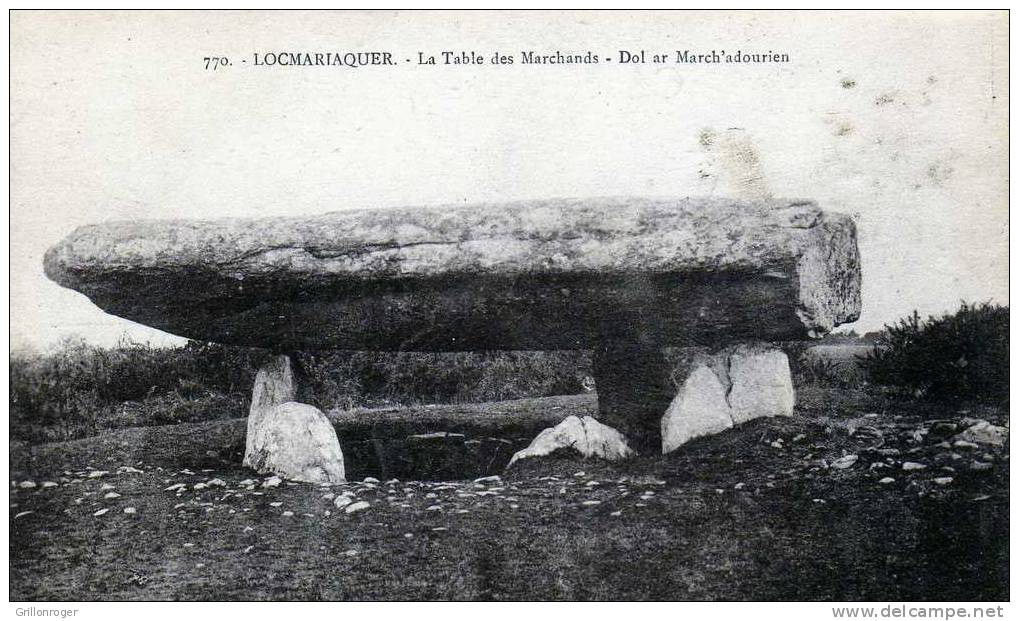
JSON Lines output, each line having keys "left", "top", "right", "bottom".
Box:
{"left": 45, "top": 198, "right": 860, "bottom": 482}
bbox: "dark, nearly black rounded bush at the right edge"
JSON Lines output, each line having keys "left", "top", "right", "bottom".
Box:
{"left": 861, "top": 302, "right": 1009, "bottom": 401}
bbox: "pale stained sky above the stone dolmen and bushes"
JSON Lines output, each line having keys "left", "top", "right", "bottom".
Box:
{"left": 10, "top": 11, "right": 1009, "bottom": 348}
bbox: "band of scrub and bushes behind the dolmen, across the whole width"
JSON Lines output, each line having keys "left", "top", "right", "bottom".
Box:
{"left": 10, "top": 303, "right": 1009, "bottom": 444}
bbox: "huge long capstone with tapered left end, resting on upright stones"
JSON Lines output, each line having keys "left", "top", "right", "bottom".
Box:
{"left": 45, "top": 198, "right": 860, "bottom": 350}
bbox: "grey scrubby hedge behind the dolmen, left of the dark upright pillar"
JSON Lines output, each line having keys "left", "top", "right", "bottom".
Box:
{"left": 10, "top": 341, "right": 591, "bottom": 443}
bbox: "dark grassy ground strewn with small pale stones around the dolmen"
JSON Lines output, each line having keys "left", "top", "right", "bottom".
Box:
{"left": 10, "top": 389, "right": 1009, "bottom": 601}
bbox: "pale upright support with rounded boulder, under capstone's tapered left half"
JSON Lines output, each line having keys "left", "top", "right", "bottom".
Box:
{"left": 244, "top": 355, "right": 345, "bottom": 483}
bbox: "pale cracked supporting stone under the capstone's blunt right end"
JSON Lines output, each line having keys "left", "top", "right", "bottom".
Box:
{"left": 661, "top": 344, "right": 795, "bottom": 453}
